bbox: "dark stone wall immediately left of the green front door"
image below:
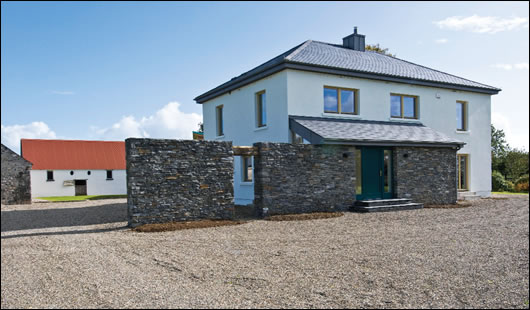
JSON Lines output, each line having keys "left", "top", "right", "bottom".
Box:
{"left": 254, "top": 143, "right": 355, "bottom": 215}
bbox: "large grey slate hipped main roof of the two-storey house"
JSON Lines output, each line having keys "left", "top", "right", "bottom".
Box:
{"left": 195, "top": 40, "right": 500, "bottom": 103}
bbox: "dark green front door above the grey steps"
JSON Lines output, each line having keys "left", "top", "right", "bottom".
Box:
{"left": 357, "top": 147, "right": 392, "bottom": 200}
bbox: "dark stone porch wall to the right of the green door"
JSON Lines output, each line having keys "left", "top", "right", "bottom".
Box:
{"left": 393, "top": 147, "right": 457, "bottom": 204}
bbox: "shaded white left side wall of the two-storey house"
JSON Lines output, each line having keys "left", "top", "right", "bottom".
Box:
{"left": 202, "top": 71, "right": 289, "bottom": 204}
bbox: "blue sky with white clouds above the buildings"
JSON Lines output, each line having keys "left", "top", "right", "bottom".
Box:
{"left": 1, "top": 1, "right": 529, "bottom": 151}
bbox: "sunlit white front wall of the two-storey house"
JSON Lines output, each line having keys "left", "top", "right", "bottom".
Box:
{"left": 287, "top": 70, "right": 491, "bottom": 196}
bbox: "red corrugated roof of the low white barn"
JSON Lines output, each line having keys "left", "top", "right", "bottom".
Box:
{"left": 20, "top": 139, "right": 125, "bottom": 170}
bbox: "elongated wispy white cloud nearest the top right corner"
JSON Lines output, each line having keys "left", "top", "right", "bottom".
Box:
{"left": 433, "top": 15, "right": 528, "bottom": 34}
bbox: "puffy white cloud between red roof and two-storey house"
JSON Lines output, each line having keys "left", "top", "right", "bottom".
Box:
{"left": 91, "top": 102, "right": 202, "bottom": 140}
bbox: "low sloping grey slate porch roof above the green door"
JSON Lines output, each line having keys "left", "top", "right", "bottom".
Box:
{"left": 289, "top": 116, "right": 465, "bottom": 146}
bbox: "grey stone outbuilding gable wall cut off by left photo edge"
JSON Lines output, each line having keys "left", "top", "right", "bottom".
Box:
{"left": 1, "top": 144, "right": 32, "bottom": 204}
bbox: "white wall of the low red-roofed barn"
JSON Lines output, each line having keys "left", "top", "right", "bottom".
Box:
{"left": 30, "top": 170, "right": 127, "bottom": 198}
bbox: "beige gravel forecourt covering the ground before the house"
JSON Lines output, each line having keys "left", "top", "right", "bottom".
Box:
{"left": 1, "top": 196, "right": 529, "bottom": 309}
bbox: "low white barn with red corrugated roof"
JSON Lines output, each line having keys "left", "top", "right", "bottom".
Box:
{"left": 20, "top": 139, "right": 127, "bottom": 197}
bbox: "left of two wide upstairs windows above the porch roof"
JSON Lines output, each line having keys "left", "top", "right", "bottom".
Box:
{"left": 324, "top": 86, "right": 359, "bottom": 115}
